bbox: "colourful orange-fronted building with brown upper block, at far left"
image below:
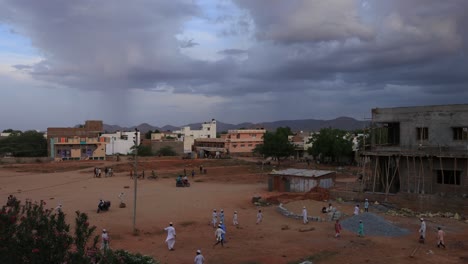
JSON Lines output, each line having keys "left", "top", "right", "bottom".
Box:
{"left": 47, "top": 120, "right": 108, "bottom": 160}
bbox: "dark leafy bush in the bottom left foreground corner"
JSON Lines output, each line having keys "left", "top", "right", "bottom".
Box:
{"left": 0, "top": 199, "right": 158, "bottom": 264}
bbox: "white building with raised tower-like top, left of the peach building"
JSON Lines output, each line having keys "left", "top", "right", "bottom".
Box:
{"left": 172, "top": 119, "right": 216, "bottom": 153}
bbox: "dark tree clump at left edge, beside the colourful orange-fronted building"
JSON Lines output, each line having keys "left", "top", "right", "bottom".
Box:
{"left": 0, "top": 130, "right": 47, "bottom": 157}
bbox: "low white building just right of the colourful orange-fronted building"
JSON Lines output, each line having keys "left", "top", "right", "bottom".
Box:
{"left": 101, "top": 131, "right": 141, "bottom": 155}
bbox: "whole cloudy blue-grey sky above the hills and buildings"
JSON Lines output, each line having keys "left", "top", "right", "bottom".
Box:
{"left": 0, "top": 0, "right": 468, "bottom": 129}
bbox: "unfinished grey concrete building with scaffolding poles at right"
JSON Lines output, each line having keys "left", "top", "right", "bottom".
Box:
{"left": 363, "top": 104, "right": 468, "bottom": 196}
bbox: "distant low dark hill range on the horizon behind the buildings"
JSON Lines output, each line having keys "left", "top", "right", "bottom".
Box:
{"left": 100, "top": 117, "right": 369, "bottom": 133}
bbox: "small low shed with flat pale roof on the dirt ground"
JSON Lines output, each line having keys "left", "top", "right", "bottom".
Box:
{"left": 268, "top": 169, "right": 336, "bottom": 192}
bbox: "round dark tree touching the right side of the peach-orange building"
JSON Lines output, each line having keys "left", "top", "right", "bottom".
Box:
{"left": 254, "top": 127, "right": 294, "bottom": 165}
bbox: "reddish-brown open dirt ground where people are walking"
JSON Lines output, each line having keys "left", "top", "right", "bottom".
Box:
{"left": 0, "top": 158, "right": 468, "bottom": 264}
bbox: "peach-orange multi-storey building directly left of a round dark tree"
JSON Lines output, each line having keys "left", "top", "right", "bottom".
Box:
{"left": 222, "top": 128, "right": 266, "bottom": 155}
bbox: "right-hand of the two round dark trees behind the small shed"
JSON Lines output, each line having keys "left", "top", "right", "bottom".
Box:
{"left": 307, "top": 128, "right": 353, "bottom": 162}
